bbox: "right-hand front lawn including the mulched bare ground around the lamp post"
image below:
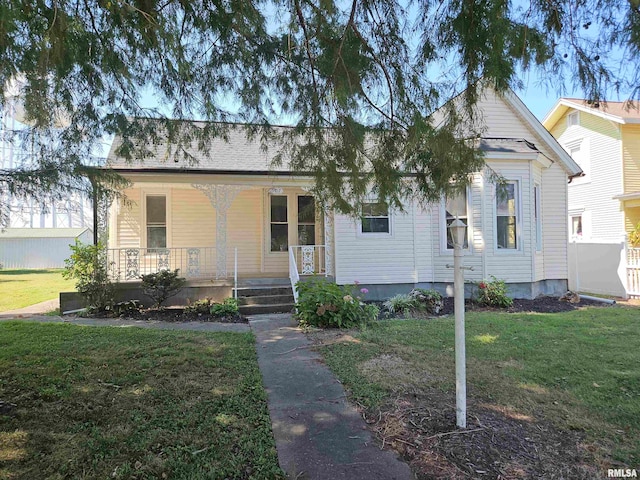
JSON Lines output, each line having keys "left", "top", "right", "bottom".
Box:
{"left": 317, "top": 307, "right": 640, "bottom": 478}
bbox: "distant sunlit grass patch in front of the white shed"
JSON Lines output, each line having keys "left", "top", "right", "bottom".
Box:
{"left": 0, "top": 270, "right": 75, "bottom": 312}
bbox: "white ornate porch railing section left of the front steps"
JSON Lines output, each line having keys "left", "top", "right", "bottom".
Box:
{"left": 107, "top": 247, "right": 220, "bottom": 281}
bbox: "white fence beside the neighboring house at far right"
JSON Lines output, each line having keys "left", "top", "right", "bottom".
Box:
{"left": 568, "top": 242, "right": 628, "bottom": 298}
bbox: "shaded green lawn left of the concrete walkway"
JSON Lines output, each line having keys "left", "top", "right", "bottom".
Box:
{"left": 0, "top": 322, "right": 283, "bottom": 480}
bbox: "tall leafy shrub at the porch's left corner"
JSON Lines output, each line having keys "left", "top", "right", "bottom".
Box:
{"left": 62, "top": 240, "right": 115, "bottom": 312}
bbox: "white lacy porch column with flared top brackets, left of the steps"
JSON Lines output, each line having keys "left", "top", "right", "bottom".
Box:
{"left": 191, "top": 183, "right": 250, "bottom": 279}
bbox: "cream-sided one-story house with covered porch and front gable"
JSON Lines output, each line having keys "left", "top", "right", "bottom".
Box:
{"left": 108, "top": 91, "right": 581, "bottom": 308}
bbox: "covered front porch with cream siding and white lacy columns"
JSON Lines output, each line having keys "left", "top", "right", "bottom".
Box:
{"left": 107, "top": 179, "right": 334, "bottom": 285}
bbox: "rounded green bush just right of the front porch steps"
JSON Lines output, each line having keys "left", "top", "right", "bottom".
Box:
{"left": 296, "top": 279, "right": 378, "bottom": 328}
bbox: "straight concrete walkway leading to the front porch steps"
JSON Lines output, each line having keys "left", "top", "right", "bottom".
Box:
{"left": 249, "top": 314, "right": 413, "bottom": 480}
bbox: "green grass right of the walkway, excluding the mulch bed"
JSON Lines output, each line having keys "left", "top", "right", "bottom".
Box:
{"left": 322, "top": 307, "right": 640, "bottom": 465}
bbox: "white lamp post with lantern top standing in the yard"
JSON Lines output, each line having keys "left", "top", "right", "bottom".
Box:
{"left": 449, "top": 217, "right": 467, "bottom": 428}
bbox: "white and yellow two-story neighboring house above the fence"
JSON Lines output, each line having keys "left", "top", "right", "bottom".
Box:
{"left": 542, "top": 98, "right": 640, "bottom": 242}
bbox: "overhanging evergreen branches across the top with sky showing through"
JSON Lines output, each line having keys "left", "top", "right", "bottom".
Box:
{"left": 0, "top": 0, "right": 640, "bottom": 218}
